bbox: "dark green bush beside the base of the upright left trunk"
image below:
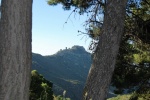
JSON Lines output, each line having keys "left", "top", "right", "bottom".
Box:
{"left": 30, "top": 70, "right": 53, "bottom": 100}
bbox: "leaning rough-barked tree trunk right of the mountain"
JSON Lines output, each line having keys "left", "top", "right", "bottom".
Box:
{"left": 83, "top": 0, "right": 127, "bottom": 100}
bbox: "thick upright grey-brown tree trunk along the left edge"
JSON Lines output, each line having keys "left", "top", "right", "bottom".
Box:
{"left": 0, "top": 0, "right": 32, "bottom": 100}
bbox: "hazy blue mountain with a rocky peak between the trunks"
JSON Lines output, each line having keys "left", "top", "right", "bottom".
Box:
{"left": 32, "top": 46, "right": 91, "bottom": 100}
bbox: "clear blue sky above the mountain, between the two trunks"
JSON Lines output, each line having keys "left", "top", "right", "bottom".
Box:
{"left": 32, "top": 0, "right": 90, "bottom": 55}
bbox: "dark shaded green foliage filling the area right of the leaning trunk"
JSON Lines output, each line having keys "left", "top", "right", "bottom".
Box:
{"left": 112, "top": 1, "right": 150, "bottom": 97}
